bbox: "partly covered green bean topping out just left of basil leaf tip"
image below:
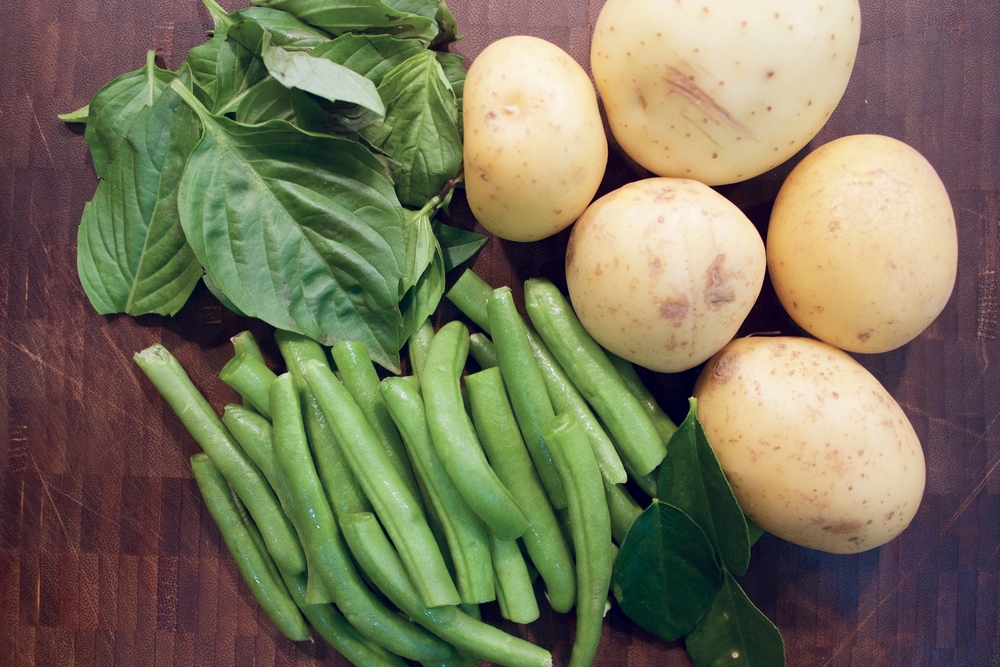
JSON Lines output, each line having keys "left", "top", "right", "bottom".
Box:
{"left": 331, "top": 341, "right": 422, "bottom": 505}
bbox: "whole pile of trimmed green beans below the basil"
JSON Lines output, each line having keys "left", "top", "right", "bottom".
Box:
{"left": 134, "top": 271, "right": 676, "bottom": 667}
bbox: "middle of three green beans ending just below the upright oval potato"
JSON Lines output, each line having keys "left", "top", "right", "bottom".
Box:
{"left": 486, "top": 287, "right": 566, "bottom": 509}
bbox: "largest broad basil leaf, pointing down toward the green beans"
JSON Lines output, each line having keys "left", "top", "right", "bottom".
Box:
{"left": 178, "top": 79, "right": 406, "bottom": 372}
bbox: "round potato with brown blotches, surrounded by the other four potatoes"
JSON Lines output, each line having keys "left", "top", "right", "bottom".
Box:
{"left": 566, "top": 177, "right": 766, "bottom": 373}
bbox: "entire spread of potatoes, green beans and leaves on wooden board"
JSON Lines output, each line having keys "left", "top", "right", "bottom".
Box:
{"left": 56, "top": 0, "right": 957, "bottom": 667}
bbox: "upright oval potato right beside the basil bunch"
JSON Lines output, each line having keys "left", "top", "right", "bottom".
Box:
{"left": 463, "top": 35, "right": 608, "bottom": 241}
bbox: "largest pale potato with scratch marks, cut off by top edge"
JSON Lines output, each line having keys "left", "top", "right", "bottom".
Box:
{"left": 591, "top": 0, "right": 861, "bottom": 185}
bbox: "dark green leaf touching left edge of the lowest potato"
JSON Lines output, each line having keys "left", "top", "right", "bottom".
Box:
{"left": 656, "top": 398, "right": 750, "bottom": 576}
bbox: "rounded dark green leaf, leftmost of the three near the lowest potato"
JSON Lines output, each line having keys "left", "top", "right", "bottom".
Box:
{"left": 611, "top": 499, "right": 722, "bottom": 641}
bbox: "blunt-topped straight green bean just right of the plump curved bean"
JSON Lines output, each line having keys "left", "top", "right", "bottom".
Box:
{"left": 465, "top": 367, "right": 576, "bottom": 613}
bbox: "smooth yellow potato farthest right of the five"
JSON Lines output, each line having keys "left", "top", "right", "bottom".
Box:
{"left": 767, "top": 135, "right": 958, "bottom": 353}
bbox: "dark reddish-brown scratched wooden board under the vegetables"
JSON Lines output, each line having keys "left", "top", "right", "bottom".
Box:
{"left": 0, "top": 0, "right": 1000, "bottom": 667}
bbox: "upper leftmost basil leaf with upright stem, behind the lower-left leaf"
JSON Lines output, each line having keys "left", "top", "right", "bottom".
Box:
{"left": 83, "top": 51, "right": 176, "bottom": 178}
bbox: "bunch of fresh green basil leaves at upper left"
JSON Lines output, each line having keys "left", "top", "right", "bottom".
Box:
{"left": 61, "top": 0, "right": 486, "bottom": 372}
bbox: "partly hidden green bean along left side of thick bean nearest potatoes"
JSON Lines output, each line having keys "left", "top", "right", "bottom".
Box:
{"left": 526, "top": 327, "right": 628, "bottom": 484}
